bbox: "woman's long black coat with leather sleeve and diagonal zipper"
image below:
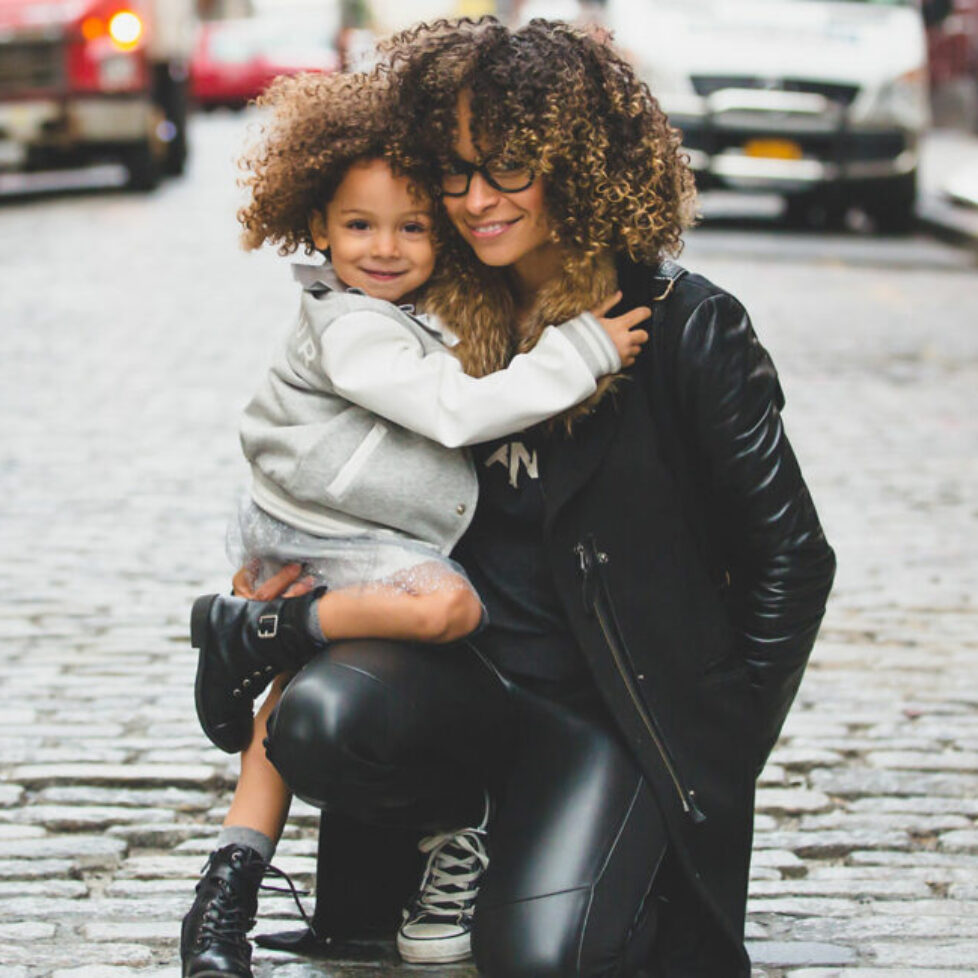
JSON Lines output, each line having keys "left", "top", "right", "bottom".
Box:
{"left": 541, "top": 263, "right": 835, "bottom": 975}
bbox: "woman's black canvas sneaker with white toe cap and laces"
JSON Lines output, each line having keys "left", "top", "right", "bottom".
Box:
{"left": 397, "top": 805, "right": 489, "bottom": 964}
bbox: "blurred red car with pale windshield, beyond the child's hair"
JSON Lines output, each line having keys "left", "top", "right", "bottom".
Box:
{"left": 190, "top": 17, "right": 340, "bottom": 109}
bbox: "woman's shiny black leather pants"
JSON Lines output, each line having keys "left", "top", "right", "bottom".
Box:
{"left": 268, "top": 641, "right": 666, "bottom": 978}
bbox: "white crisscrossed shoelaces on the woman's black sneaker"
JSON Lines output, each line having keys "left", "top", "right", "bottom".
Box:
{"left": 415, "top": 829, "right": 489, "bottom": 916}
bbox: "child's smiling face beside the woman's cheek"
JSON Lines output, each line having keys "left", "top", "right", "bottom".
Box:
{"left": 309, "top": 160, "right": 435, "bottom": 302}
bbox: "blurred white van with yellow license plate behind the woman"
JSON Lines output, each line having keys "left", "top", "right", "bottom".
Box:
{"left": 606, "top": 0, "right": 930, "bottom": 231}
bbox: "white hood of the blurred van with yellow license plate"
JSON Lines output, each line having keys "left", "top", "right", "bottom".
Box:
{"left": 608, "top": 0, "right": 925, "bottom": 85}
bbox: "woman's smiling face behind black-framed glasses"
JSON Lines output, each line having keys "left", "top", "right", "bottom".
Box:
{"left": 442, "top": 92, "right": 561, "bottom": 287}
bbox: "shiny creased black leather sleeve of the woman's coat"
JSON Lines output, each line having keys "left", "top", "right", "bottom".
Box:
{"left": 676, "top": 293, "right": 835, "bottom": 766}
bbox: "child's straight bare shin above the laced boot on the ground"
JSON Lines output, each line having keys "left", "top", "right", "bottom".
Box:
{"left": 215, "top": 674, "right": 292, "bottom": 860}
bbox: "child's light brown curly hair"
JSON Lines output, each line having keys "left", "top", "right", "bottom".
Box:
{"left": 238, "top": 71, "right": 421, "bottom": 255}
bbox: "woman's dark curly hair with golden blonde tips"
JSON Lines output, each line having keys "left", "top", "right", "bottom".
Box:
{"left": 385, "top": 17, "right": 694, "bottom": 262}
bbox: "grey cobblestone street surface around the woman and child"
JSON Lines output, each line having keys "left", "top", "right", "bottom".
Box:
{"left": 0, "top": 110, "right": 978, "bottom": 978}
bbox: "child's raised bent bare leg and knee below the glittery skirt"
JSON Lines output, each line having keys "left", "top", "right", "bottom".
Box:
{"left": 318, "top": 575, "right": 482, "bottom": 642}
